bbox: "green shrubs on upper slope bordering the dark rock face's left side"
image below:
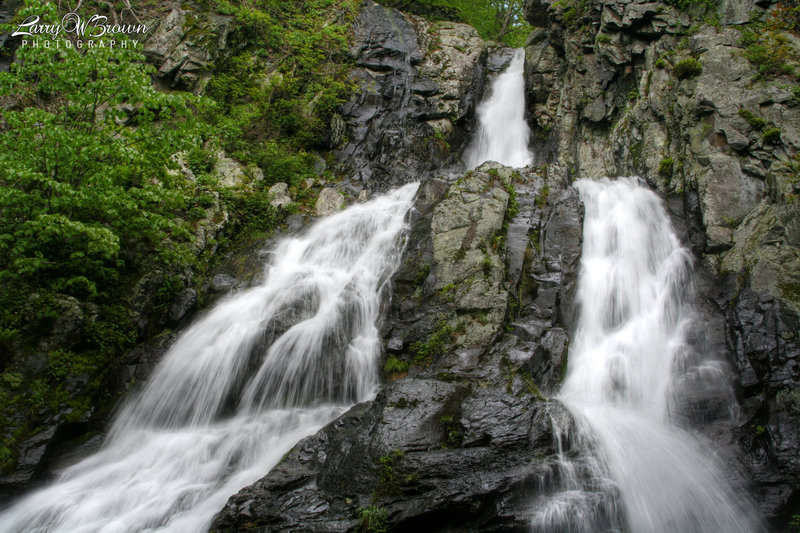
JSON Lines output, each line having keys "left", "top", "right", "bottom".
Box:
{"left": 207, "top": 0, "right": 356, "bottom": 181}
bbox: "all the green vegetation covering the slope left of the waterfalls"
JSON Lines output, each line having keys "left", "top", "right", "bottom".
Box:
{"left": 0, "top": 0, "right": 356, "bottom": 473}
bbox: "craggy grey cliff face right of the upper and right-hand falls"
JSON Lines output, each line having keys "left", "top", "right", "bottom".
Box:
{"left": 526, "top": 0, "right": 800, "bottom": 528}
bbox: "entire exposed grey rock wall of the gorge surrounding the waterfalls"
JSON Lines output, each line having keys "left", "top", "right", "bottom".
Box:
{"left": 5, "top": 0, "right": 800, "bottom": 531}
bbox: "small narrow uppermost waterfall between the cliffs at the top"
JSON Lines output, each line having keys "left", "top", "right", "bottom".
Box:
{"left": 464, "top": 48, "right": 533, "bottom": 168}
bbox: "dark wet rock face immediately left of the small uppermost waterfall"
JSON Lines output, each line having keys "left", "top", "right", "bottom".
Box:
{"left": 331, "top": 0, "right": 494, "bottom": 195}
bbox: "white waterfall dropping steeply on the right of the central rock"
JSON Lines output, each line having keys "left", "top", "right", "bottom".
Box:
{"left": 534, "top": 179, "right": 764, "bottom": 533}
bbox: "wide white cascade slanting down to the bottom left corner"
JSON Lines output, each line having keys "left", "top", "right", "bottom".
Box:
{"left": 0, "top": 184, "right": 417, "bottom": 533}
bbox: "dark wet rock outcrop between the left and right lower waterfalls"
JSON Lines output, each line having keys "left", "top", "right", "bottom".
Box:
{"left": 212, "top": 163, "right": 582, "bottom": 531}
